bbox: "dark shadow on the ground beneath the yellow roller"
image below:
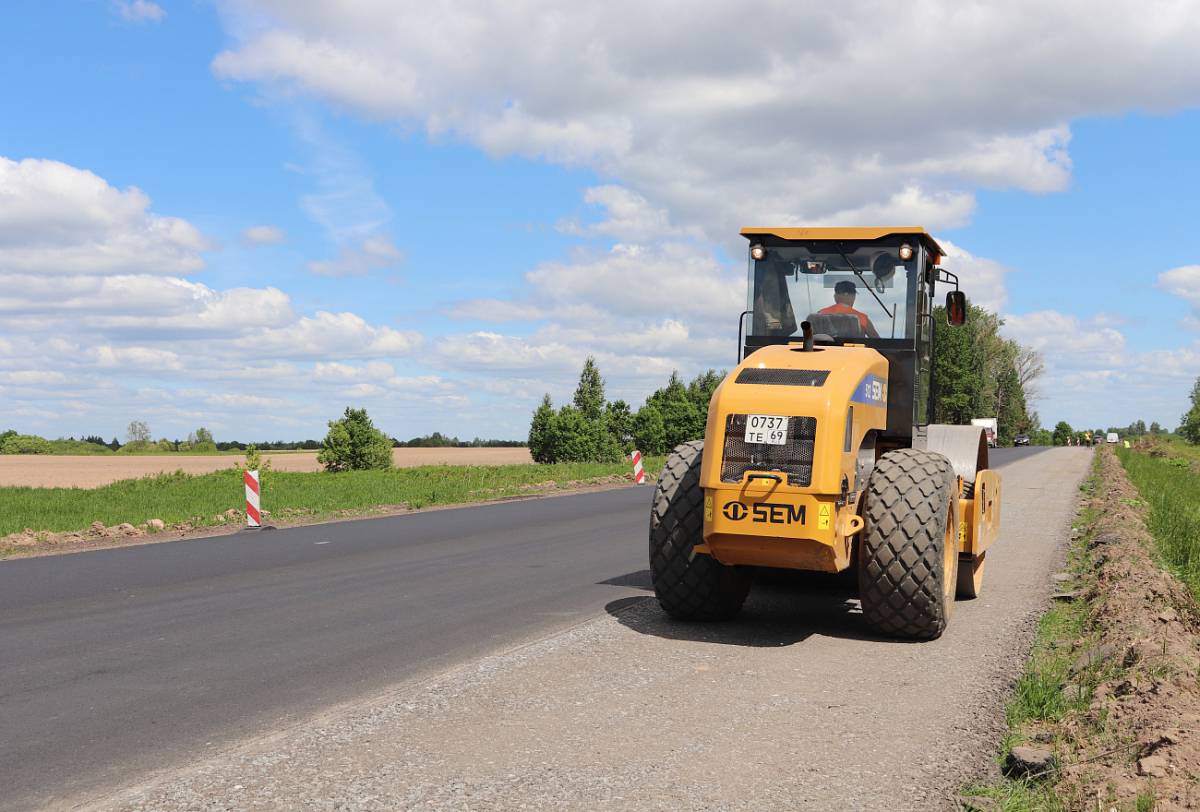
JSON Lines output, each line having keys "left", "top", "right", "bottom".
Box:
{"left": 600, "top": 570, "right": 895, "bottom": 648}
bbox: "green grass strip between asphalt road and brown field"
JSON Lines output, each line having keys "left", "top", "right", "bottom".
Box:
{"left": 0, "top": 458, "right": 664, "bottom": 536}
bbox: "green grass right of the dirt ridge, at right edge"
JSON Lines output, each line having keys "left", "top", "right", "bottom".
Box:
{"left": 1116, "top": 443, "right": 1200, "bottom": 600}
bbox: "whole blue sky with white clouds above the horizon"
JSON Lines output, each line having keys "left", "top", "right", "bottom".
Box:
{"left": 0, "top": 0, "right": 1200, "bottom": 439}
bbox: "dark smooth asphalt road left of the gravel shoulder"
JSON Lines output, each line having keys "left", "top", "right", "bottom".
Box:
{"left": 0, "top": 449, "right": 1040, "bottom": 808}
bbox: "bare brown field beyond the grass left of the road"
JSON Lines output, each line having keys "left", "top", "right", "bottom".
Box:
{"left": 0, "top": 449, "right": 533, "bottom": 488}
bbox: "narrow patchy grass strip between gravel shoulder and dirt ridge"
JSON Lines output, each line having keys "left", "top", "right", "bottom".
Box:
{"left": 961, "top": 448, "right": 1099, "bottom": 812}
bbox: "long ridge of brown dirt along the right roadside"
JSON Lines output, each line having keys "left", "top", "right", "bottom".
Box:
{"left": 1060, "top": 451, "right": 1200, "bottom": 812}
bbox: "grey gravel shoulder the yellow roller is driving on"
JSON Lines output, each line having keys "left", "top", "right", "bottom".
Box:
{"left": 89, "top": 449, "right": 1091, "bottom": 811}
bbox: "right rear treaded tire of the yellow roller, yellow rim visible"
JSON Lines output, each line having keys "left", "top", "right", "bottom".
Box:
{"left": 858, "top": 449, "right": 959, "bottom": 640}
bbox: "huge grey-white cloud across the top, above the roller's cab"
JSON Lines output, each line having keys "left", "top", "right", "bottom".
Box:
{"left": 212, "top": 0, "right": 1200, "bottom": 240}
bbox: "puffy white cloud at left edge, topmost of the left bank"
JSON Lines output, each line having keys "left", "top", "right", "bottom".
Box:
{"left": 0, "top": 156, "right": 209, "bottom": 275}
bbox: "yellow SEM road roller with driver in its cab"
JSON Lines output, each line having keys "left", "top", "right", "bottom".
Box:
{"left": 650, "top": 228, "right": 1000, "bottom": 639}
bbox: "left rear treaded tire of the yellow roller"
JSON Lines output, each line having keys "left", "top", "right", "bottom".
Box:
{"left": 650, "top": 440, "right": 750, "bottom": 620}
